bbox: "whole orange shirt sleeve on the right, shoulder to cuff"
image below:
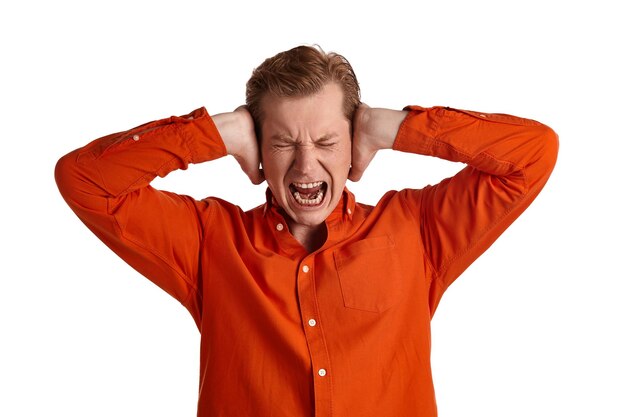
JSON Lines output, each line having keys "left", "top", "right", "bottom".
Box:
{"left": 394, "top": 106, "right": 558, "bottom": 312}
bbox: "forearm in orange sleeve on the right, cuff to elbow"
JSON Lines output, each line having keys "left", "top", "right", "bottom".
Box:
{"left": 393, "top": 106, "right": 558, "bottom": 185}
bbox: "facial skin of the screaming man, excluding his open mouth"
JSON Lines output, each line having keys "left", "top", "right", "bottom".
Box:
{"left": 261, "top": 83, "right": 351, "bottom": 237}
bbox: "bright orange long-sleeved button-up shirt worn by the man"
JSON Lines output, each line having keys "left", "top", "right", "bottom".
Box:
{"left": 56, "top": 106, "right": 558, "bottom": 417}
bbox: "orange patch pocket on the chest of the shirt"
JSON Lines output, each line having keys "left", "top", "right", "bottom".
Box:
{"left": 333, "top": 236, "right": 402, "bottom": 313}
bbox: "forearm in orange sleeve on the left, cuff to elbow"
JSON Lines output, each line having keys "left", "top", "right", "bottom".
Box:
{"left": 55, "top": 108, "right": 226, "bottom": 207}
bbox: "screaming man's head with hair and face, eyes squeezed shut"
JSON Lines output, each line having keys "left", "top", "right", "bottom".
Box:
{"left": 246, "top": 46, "right": 360, "bottom": 227}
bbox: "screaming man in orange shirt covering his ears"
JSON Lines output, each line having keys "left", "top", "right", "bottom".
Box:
{"left": 56, "top": 47, "right": 558, "bottom": 417}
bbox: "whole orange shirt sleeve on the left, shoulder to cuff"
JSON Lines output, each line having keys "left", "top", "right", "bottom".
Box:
{"left": 55, "top": 108, "right": 226, "bottom": 322}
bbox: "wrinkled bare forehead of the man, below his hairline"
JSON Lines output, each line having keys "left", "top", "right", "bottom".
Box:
{"left": 261, "top": 83, "right": 349, "bottom": 137}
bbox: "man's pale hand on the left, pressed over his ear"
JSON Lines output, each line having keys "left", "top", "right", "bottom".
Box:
{"left": 211, "top": 106, "right": 265, "bottom": 184}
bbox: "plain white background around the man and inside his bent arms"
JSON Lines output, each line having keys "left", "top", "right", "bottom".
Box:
{"left": 0, "top": 0, "right": 626, "bottom": 417}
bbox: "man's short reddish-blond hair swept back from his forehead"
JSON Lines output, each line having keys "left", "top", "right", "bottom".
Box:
{"left": 246, "top": 45, "right": 361, "bottom": 139}
